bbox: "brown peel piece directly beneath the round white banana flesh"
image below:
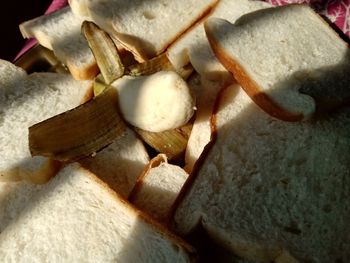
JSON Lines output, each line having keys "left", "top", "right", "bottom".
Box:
{"left": 134, "top": 123, "right": 193, "bottom": 160}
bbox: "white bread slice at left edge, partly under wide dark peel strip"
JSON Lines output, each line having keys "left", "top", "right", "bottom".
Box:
{"left": 0, "top": 73, "right": 91, "bottom": 183}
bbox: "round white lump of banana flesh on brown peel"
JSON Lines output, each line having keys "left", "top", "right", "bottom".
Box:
{"left": 111, "top": 71, "right": 195, "bottom": 132}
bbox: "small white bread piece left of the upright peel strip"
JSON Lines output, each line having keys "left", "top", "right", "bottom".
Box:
{"left": 19, "top": 6, "right": 98, "bottom": 80}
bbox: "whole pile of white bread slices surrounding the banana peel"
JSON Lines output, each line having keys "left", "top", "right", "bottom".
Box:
{"left": 0, "top": 0, "right": 350, "bottom": 263}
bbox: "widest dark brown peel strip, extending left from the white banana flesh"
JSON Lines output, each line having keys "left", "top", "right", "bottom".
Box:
{"left": 29, "top": 88, "right": 126, "bottom": 162}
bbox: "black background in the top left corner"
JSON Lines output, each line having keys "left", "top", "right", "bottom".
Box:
{"left": 0, "top": 0, "right": 52, "bottom": 61}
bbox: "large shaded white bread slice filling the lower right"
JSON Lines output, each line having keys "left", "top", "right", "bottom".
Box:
{"left": 174, "top": 86, "right": 350, "bottom": 263}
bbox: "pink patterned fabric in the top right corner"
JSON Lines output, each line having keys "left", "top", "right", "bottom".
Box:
{"left": 266, "top": 0, "right": 350, "bottom": 38}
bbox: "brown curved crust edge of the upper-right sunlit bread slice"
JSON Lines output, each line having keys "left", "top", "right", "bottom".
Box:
{"left": 204, "top": 24, "right": 304, "bottom": 122}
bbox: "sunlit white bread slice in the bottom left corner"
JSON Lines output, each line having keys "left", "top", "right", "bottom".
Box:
{"left": 0, "top": 164, "right": 194, "bottom": 262}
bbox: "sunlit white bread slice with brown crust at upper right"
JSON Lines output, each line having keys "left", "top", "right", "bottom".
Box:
{"left": 205, "top": 5, "right": 350, "bottom": 121}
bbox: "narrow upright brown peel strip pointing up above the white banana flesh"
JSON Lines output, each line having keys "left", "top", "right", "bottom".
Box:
{"left": 81, "top": 21, "right": 124, "bottom": 84}
